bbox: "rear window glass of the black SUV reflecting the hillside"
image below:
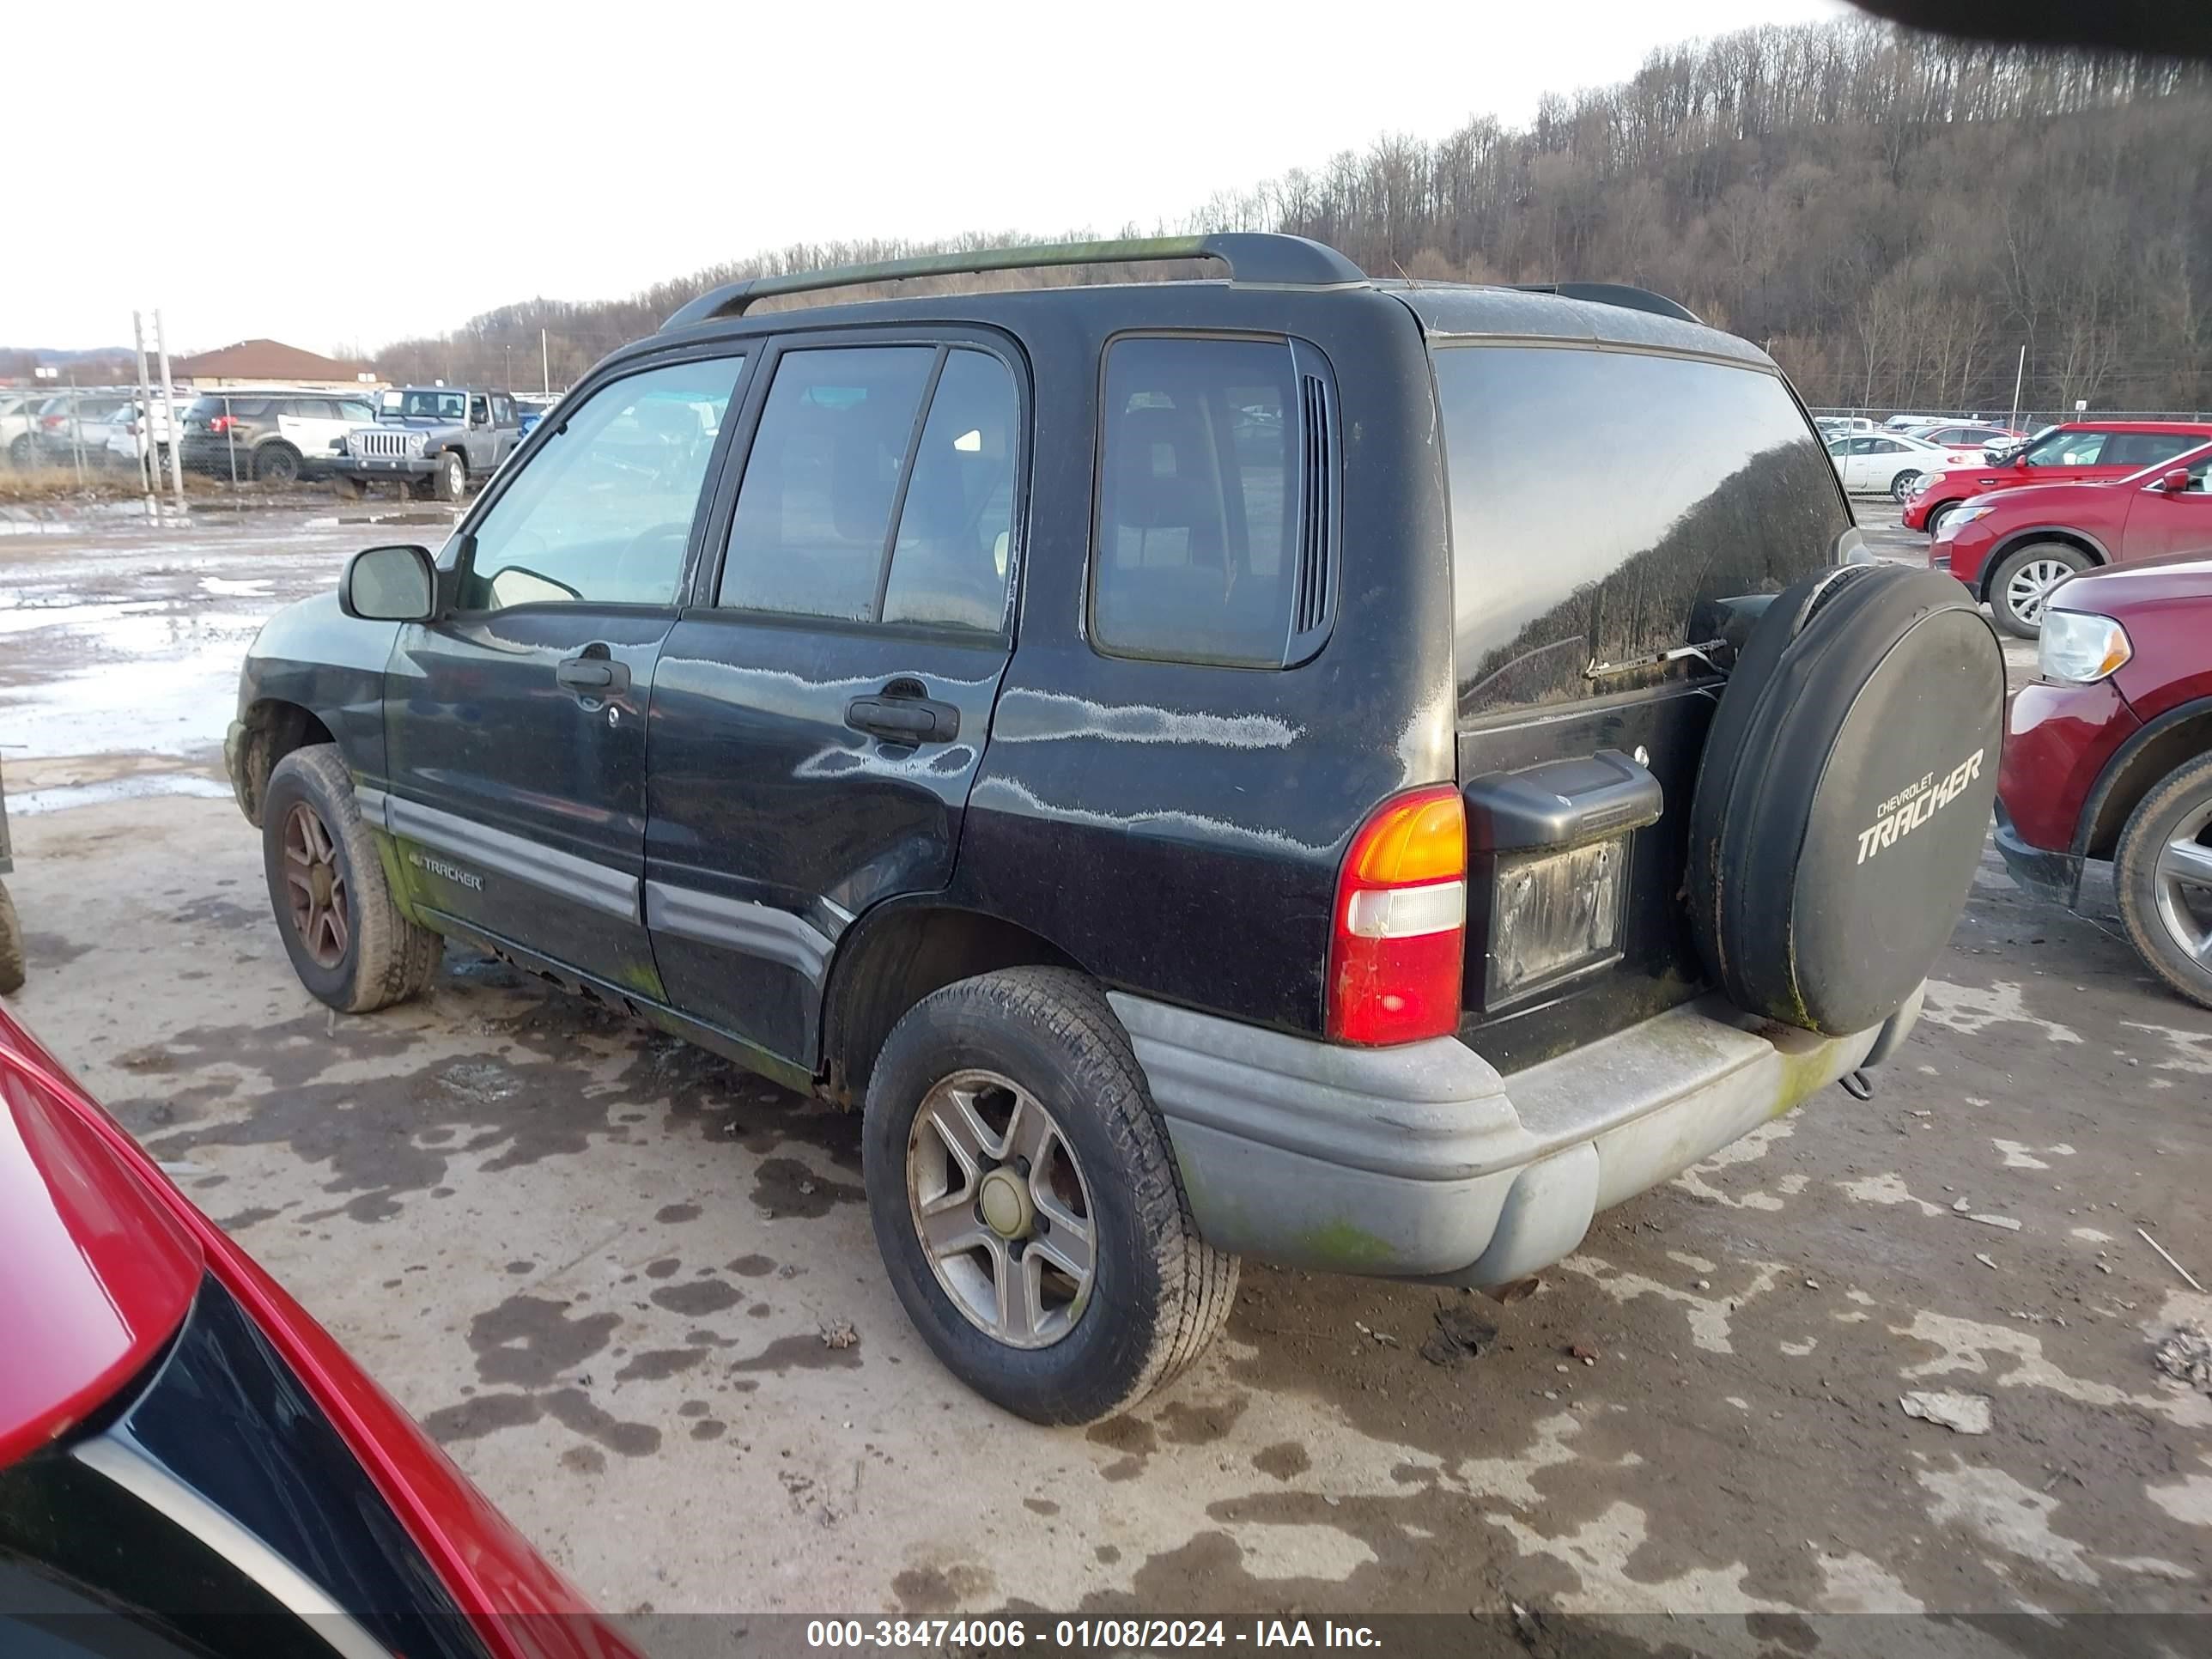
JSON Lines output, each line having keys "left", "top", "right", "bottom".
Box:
{"left": 1436, "top": 345, "right": 1850, "bottom": 719}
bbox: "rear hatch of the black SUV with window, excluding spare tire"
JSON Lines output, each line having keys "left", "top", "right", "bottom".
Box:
{"left": 1431, "top": 309, "right": 1851, "bottom": 1071}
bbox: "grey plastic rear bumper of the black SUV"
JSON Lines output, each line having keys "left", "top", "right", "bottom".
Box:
{"left": 1110, "top": 994, "right": 1920, "bottom": 1285}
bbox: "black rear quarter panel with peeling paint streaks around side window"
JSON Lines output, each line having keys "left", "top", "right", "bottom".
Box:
{"left": 951, "top": 285, "right": 1453, "bottom": 1033}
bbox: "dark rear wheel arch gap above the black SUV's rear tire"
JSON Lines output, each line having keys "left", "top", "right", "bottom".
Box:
{"left": 817, "top": 894, "right": 1082, "bottom": 1106}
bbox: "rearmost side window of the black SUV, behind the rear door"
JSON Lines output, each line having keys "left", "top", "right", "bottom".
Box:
{"left": 1091, "top": 338, "right": 1336, "bottom": 668}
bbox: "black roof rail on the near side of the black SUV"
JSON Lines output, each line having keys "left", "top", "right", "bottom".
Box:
{"left": 661, "top": 230, "right": 1367, "bottom": 334}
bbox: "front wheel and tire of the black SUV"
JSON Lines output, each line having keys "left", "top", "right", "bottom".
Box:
{"left": 261, "top": 744, "right": 445, "bottom": 1013}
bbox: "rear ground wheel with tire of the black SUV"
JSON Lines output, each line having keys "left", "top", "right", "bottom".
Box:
{"left": 863, "top": 967, "right": 1237, "bottom": 1422}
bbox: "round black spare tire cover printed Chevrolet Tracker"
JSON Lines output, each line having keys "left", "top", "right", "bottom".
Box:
{"left": 1687, "top": 564, "right": 2004, "bottom": 1037}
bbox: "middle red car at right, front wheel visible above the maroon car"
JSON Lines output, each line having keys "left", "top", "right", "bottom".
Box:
{"left": 1929, "top": 445, "right": 2212, "bottom": 639}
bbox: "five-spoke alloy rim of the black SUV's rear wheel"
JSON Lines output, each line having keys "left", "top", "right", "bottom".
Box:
{"left": 907, "top": 1071, "right": 1097, "bottom": 1347}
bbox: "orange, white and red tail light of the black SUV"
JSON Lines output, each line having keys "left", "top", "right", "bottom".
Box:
{"left": 1328, "top": 785, "right": 1467, "bottom": 1044}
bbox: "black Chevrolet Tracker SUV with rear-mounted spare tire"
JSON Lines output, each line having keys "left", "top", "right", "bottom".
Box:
{"left": 228, "top": 234, "right": 2004, "bottom": 1422}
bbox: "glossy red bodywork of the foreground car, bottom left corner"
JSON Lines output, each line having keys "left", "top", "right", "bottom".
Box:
{"left": 0, "top": 1006, "right": 635, "bottom": 1659}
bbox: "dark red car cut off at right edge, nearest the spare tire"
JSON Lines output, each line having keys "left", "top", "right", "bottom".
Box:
{"left": 1997, "top": 560, "right": 2212, "bottom": 1006}
